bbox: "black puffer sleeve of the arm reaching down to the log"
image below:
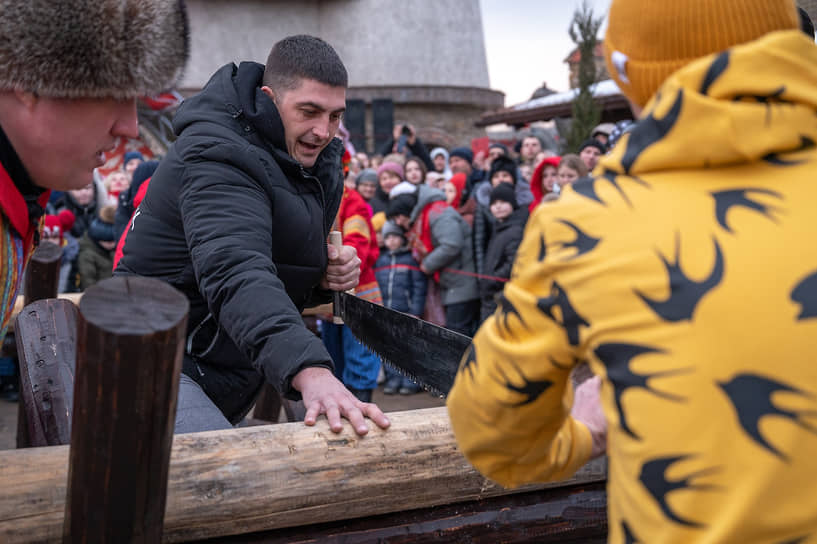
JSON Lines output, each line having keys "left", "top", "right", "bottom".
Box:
{"left": 179, "top": 155, "right": 332, "bottom": 397}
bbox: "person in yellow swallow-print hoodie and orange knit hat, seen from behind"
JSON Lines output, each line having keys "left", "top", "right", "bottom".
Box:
{"left": 448, "top": 0, "right": 817, "bottom": 543}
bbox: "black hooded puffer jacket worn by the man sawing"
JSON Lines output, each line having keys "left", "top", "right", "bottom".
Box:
{"left": 116, "top": 62, "right": 343, "bottom": 421}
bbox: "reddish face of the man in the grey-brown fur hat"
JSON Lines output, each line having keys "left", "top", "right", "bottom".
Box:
{"left": 4, "top": 92, "right": 139, "bottom": 191}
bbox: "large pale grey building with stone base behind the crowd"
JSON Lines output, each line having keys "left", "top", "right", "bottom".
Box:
{"left": 179, "top": 0, "right": 504, "bottom": 151}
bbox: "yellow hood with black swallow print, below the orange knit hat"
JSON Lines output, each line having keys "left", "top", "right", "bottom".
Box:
{"left": 594, "top": 30, "right": 817, "bottom": 175}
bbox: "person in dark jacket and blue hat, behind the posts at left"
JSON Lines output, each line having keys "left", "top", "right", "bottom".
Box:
{"left": 77, "top": 206, "right": 116, "bottom": 291}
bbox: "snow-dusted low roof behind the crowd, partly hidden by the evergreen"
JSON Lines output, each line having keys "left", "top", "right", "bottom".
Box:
{"left": 475, "top": 79, "right": 629, "bottom": 127}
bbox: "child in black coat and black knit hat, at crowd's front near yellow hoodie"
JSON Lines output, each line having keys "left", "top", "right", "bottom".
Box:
{"left": 479, "top": 183, "right": 528, "bottom": 322}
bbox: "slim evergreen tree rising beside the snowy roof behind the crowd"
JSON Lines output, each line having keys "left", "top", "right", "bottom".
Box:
{"left": 567, "top": 0, "right": 604, "bottom": 153}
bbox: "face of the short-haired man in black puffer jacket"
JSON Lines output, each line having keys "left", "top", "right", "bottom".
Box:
{"left": 261, "top": 79, "right": 346, "bottom": 168}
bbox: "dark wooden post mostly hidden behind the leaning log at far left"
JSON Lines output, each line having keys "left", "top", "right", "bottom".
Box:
{"left": 17, "top": 242, "right": 62, "bottom": 448}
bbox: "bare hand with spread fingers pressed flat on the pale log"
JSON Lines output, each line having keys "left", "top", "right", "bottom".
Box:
{"left": 292, "top": 367, "right": 391, "bottom": 436}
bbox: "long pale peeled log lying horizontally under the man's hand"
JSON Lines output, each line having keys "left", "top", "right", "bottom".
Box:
{"left": 0, "top": 407, "right": 606, "bottom": 542}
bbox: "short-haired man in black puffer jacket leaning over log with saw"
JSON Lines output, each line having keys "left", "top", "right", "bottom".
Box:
{"left": 116, "top": 36, "right": 389, "bottom": 435}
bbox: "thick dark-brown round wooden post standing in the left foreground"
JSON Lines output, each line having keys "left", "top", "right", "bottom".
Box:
{"left": 63, "top": 277, "right": 189, "bottom": 542}
